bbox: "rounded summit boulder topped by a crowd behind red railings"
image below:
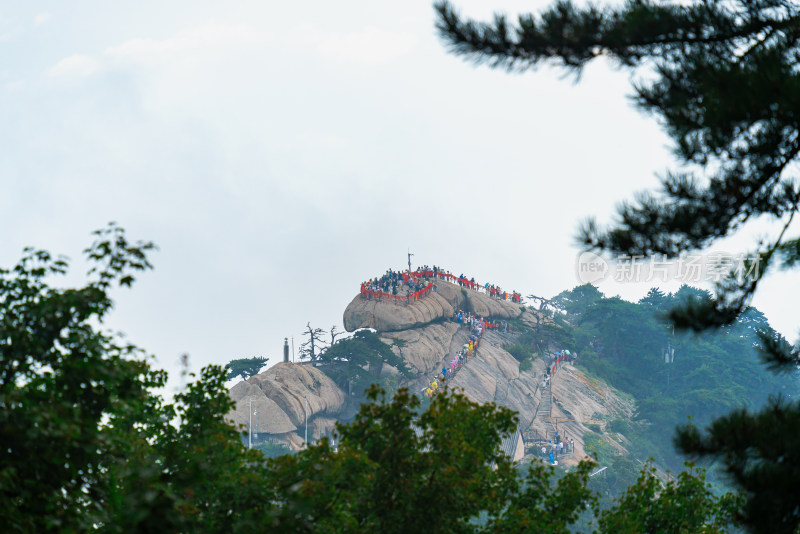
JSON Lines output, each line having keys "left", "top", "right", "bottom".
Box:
{"left": 344, "top": 280, "right": 522, "bottom": 332}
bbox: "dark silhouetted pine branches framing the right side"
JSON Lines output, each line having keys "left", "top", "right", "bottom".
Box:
{"left": 435, "top": 0, "right": 800, "bottom": 532}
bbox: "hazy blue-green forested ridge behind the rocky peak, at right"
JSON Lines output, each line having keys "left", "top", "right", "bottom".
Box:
{"left": 547, "top": 284, "right": 798, "bottom": 469}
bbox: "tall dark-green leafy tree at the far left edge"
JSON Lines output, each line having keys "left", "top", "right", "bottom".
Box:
{"left": 0, "top": 226, "right": 158, "bottom": 532}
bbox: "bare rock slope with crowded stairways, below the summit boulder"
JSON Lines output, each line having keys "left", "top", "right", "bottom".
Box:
{"left": 382, "top": 310, "right": 634, "bottom": 466}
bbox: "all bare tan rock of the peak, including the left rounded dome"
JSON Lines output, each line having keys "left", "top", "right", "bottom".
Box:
{"left": 231, "top": 280, "right": 633, "bottom": 465}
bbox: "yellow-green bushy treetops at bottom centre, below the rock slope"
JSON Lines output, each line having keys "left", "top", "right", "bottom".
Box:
{"left": 269, "top": 388, "right": 608, "bottom": 533}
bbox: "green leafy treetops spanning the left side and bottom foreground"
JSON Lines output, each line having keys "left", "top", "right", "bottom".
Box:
{"left": 0, "top": 225, "right": 744, "bottom": 533}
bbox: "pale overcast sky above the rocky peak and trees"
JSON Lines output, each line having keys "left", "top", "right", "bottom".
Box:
{"left": 0, "top": 0, "right": 799, "bottom": 394}
